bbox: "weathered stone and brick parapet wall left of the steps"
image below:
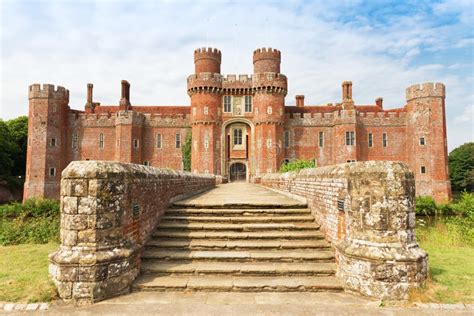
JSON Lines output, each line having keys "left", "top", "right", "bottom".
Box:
{"left": 49, "top": 161, "right": 216, "bottom": 304}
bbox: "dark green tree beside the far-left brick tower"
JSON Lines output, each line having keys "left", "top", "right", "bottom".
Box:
{"left": 6, "top": 116, "right": 28, "bottom": 176}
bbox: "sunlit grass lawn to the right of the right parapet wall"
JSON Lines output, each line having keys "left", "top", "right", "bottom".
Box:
{"left": 412, "top": 224, "right": 474, "bottom": 303}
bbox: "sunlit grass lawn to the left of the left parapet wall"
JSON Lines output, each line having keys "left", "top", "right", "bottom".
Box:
{"left": 0, "top": 243, "right": 58, "bottom": 303}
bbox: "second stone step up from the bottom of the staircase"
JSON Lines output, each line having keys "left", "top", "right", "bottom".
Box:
{"left": 141, "top": 259, "right": 336, "bottom": 276}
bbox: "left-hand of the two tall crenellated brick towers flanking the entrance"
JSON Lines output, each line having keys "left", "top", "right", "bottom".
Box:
{"left": 188, "top": 48, "right": 222, "bottom": 174}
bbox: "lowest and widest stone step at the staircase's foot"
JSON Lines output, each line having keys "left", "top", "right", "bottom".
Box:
{"left": 133, "top": 274, "right": 343, "bottom": 292}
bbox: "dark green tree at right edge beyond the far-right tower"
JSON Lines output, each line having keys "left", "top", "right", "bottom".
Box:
{"left": 449, "top": 143, "right": 474, "bottom": 192}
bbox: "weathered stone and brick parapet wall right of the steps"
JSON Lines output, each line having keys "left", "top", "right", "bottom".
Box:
{"left": 262, "top": 161, "right": 427, "bottom": 299}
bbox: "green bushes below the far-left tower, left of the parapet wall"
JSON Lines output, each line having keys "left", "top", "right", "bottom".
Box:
{"left": 0, "top": 199, "right": 59, "bottom": 245}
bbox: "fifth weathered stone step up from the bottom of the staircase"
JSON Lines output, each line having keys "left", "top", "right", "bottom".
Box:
{"left": 152, "top": 230, "right": 324, "bottom": 239}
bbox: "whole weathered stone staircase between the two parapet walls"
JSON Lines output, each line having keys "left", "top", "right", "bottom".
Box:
{"left": 133, "top": 193, "right": 343, "bottom": 292}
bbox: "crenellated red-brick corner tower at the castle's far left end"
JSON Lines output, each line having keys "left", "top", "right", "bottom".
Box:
{"left": 23, "top": 84, "right": 69, "bottom": 200}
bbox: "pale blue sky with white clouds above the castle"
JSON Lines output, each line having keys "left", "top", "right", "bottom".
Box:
{"left": 0, "top": 0, "right": 474, "bottom": 150}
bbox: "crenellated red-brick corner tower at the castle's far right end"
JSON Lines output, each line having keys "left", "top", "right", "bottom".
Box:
{"left": 406, "top": 82, "right": 451, "bottom": 201}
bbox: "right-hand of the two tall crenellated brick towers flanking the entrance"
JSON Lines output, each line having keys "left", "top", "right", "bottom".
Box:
{"left": 252, "top": 48, "right": 288, "bottom": 176}
